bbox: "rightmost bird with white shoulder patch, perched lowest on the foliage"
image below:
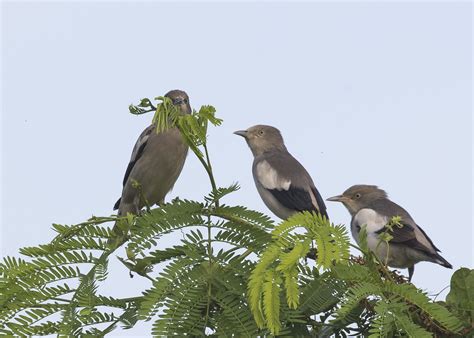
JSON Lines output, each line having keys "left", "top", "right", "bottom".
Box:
{"left": 327, "top": 185, "right": 452, "bottom": 280}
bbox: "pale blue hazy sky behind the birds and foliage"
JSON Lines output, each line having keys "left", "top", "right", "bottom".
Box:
{"left": 0, "top": 2, "right": 473, "bottom": 335}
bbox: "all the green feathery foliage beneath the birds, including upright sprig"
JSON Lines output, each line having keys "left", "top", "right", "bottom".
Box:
{"left": 0, "top": 97, "right": 468, "bottom": 337}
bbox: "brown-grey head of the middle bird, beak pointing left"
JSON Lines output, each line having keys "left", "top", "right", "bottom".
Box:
{"left": 234, "top": 124, "right": 286, "bottom": 156}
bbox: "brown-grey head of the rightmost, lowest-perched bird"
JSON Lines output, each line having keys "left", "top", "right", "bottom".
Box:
{"left": 327, "top": 184, "right": 387, "bottom": 216}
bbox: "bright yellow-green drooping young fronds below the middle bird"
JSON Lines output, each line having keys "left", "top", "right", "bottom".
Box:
{"left": 248, "top": 212, "right": 349, "bottom": 334}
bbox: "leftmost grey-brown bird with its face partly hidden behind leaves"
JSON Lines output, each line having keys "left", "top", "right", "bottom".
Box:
{"left": 114, "top": 90, "right": 191, "bottom": 215}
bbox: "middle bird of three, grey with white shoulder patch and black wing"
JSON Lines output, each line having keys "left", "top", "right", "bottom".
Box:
{"left": 234, "top": 125, "right": 328, "bottom": 219}
